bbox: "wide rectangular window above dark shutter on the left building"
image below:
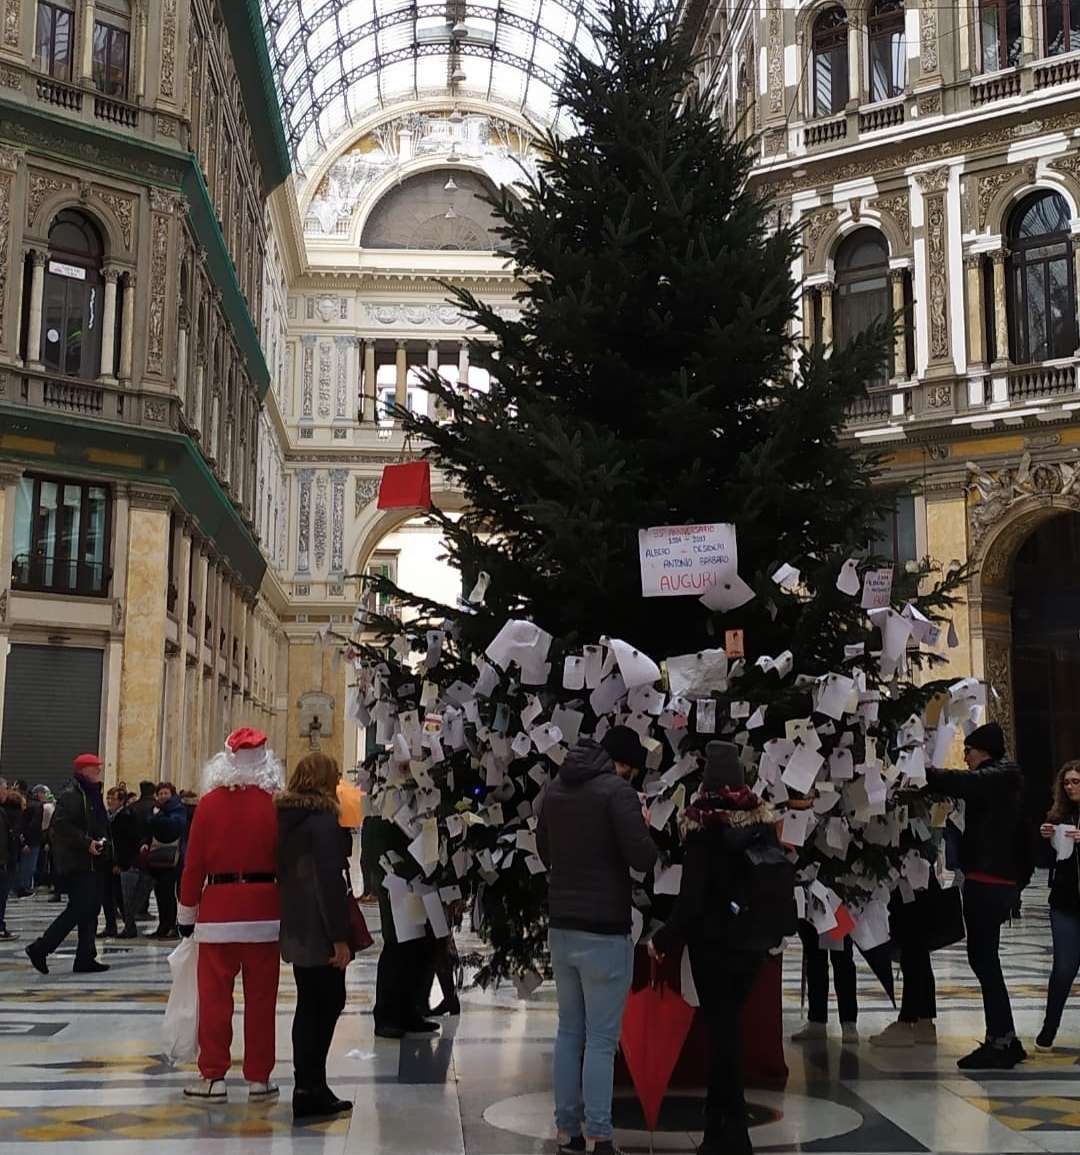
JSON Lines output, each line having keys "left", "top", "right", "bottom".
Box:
{"left": 12, "top": 477, "right": 111, "bottom": 597}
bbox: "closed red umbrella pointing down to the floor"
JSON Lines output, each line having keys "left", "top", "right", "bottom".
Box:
{"left": 619, "top": 967, "right": 694, "bottom": 1131}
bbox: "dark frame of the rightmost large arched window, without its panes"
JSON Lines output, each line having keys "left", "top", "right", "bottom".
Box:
{"left": 1006, "top": 189, "right": 1078, "bottom": 365}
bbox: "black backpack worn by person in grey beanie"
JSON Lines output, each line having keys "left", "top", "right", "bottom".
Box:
{"left": 728, "top": 839, "right": 798, "bottom": 951}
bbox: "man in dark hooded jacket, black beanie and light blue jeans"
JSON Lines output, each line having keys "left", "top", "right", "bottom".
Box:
{"left": 536, "top": 726, "right": 656, "bottom": 1153}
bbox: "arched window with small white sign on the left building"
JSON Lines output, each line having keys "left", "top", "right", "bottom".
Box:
{"left": 42, "top": 209, "right": 105, "bottom": 378}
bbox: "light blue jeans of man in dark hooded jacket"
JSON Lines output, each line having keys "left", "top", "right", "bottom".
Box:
{"left": 548, "top": 927, "right": 634, "bottom": 1139}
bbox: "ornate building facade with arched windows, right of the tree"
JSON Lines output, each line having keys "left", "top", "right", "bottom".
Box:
{"left": 680, "top": 0, "right": 1080, "bottom": 799}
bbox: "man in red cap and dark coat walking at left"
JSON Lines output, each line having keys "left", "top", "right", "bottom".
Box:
{"left": 27, "top": 754, "right": 112, "bottom": 975}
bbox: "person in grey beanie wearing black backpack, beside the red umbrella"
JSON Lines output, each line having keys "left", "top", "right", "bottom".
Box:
{"left": 649, "top": 742, "right": 796, "bottom": 1155}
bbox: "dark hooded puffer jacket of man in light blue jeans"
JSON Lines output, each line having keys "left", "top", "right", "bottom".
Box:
{"left": 536, "top": 740, "right": 656, "bottom": 934}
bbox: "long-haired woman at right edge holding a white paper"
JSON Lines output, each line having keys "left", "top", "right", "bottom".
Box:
{"left": 1035, "top": 761, "right": 1080, "bottom": 1051}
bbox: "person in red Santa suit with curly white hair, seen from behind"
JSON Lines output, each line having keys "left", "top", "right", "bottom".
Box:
{"left": 177, "top": 728, "right": 284, "bottom": 1102}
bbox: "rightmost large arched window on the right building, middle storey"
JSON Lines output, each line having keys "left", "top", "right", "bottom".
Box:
{"left": 1008, "top": 193, "right": 1077, "bottom": 365}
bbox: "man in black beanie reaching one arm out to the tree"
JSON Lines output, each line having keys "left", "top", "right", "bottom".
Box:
{"left": 926, "top": 722, "right": 1030, "bottom": 1071}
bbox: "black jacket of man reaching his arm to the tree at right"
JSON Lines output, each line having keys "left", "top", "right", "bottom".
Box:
{"left": 926, "top": 761, "right": 1031, "bottom": 885}
